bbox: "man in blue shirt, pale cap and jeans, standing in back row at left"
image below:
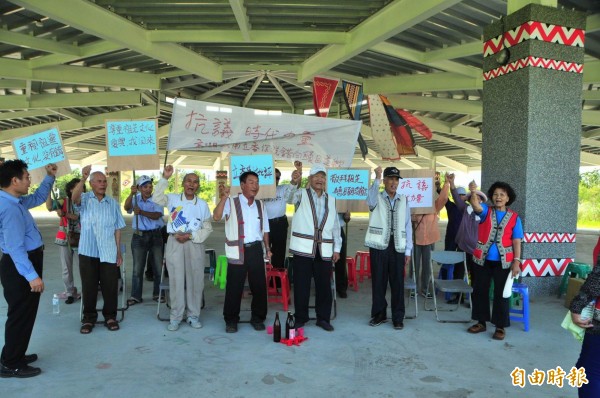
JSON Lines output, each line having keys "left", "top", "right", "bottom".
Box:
{"left": 123, "top": 175, "right": 165, "bottom": 306}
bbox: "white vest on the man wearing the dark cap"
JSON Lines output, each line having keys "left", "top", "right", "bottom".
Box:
{"left": 365, "top": 191, "right": 406, "bottom": 253}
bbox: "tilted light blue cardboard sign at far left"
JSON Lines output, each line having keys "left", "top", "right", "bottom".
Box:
{"left": 12, "top": 127, "right": 71, "bottom": 184}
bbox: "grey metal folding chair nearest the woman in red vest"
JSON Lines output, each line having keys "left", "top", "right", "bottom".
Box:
{"left": 425, "top": 251, "right": 473, "bottom": 323}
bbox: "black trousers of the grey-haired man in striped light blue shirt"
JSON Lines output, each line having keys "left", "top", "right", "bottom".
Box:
{"left": 79, "top": 254, "right": 121, "bottom": 323}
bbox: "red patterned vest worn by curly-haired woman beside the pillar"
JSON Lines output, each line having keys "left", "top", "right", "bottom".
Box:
{"left": 473, "top": 207, "right": 518, "bottom": 269}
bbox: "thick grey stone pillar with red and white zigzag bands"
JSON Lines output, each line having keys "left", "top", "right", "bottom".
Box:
{"left": 482, "top": 4, "right": 585, "bottom": 292}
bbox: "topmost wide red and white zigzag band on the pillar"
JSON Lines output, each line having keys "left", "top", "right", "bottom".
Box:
{"left": 483, "top": 21, "right": 585, "bottom": 57}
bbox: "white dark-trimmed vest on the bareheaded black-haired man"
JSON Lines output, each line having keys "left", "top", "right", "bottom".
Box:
{"left": 225, "top": 196, "right": 264, "bottom": 264}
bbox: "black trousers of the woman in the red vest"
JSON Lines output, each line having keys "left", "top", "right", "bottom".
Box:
{"left": 471, "top": 260, "right": 510, "bottom": 328}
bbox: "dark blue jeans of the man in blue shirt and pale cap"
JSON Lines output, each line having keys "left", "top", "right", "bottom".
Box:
{"left": 131, "top": 228, "right": 163, "bottom": 301}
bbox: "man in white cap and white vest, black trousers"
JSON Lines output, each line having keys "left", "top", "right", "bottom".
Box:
{"left": 288, "top": 164, "right": 342, "bottom": 332}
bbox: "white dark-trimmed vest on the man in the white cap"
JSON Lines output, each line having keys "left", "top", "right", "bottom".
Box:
{"left": 290, "top": 188, "right": 337, "bottom": 260}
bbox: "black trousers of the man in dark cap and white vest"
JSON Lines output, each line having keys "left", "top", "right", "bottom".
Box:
{"left": 369, "top": 237, "right": 405, "bottom": 322}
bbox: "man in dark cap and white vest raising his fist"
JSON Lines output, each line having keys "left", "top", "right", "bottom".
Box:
{"left": 365, "top": 166, "right": 413, "bottom": 330}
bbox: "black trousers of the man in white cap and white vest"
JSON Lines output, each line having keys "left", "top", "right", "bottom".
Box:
{"left": 293, "top": 250, "right": 333, "bottom": 323}
